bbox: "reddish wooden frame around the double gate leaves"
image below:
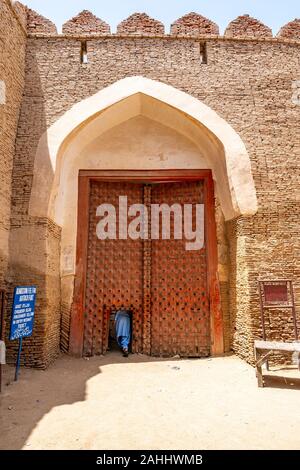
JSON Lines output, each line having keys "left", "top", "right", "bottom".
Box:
{"left": 69, "top": 169, "right": 224, "bottom": 357}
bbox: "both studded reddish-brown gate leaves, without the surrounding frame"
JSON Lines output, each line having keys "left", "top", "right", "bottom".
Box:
{"left": 84, "top": 181, "right": 210, "bottom": 357}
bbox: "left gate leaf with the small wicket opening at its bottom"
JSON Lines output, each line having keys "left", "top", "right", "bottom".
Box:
{"left": 84, "top": 182, "right": 143, "bottom": 355}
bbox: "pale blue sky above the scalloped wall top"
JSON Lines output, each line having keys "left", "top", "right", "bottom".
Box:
{"left": 23, "top": 0, "right": 300, "bottom": 33}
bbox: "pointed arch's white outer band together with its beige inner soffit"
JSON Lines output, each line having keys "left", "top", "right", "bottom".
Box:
{"left": 29, "top": 76, "right": 257, "bottom": 225}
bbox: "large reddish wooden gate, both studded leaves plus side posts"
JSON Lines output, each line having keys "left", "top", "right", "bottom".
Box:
{"left": 70, "top": 170, "right": 223, "bottom": 357}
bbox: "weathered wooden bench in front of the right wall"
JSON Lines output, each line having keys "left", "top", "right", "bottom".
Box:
{"left": 254, "top": 341, "right": 300, "bottom": 387}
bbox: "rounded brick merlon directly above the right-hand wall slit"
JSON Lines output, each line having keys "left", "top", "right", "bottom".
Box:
{"left": 171, "top": 13, "right": 219, "bottom": 36}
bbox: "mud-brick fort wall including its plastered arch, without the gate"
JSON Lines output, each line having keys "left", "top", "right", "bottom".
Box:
{"left": 0, "top": 0, "right": 300, "bottom": 368}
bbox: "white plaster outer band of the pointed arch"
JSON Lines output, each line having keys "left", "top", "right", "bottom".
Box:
{"left": 29, "top": 76, "right": 257, "bottom": 223}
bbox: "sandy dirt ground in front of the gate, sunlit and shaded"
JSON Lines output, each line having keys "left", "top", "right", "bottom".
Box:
{"left": 0, "top": 352, "right": 300, "bottom": 450}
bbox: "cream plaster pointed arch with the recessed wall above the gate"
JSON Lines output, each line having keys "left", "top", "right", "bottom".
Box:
{"left": 29, "top": 77, "right": 257, "bottom": 351}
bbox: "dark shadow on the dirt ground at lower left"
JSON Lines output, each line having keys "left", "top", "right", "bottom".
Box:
{"left": 0, "top": 348, "right": 199, "bottom": 450}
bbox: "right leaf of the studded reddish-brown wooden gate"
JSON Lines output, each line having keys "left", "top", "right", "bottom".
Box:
{"left": 151, "top": 182, "right": 210, "bottom": 357}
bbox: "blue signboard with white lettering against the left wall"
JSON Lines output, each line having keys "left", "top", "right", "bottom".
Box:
{"left": 9, "top": 286, "right": 36, "bottom": 341}
